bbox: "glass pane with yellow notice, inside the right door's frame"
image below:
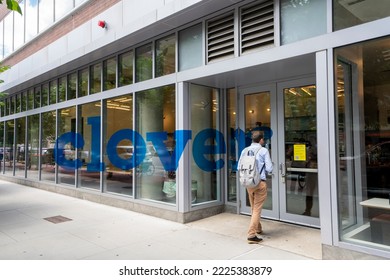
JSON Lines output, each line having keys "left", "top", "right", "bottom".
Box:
{"left": 283, "top": 85, "right": 319, "bottom": 218}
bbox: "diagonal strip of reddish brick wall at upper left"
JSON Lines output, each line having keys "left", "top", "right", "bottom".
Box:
{"left": 0, "top": 0, "right": 121, "bottom": 66}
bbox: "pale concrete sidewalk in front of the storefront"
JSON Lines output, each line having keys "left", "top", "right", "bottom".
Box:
{"left": 0, "top": 180, "right": 321, "bottom": 260}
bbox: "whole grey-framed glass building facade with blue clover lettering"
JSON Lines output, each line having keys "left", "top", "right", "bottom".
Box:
{"left": 0, "top": 0, "right": 390, "bottom": 259}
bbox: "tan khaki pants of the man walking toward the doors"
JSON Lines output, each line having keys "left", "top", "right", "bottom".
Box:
{"left": 247, "top": 181, "right": 267, "bottom": 238}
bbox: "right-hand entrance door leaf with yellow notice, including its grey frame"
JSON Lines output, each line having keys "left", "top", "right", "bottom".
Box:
{"left": 274, "top": 79, "right": 319, "bottom": 227}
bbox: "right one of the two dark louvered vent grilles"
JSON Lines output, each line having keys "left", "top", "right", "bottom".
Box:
{"left": 241, "top": 0, "right": 274, "bottom": 53}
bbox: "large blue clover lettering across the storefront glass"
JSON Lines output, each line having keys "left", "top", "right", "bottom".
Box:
{"left": 55, "top": 117, "right": 256, "bottom": 172}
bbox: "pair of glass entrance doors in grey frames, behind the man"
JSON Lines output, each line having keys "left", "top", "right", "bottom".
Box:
{"left": 239, "top": 79, "right": 319, "bottom": 227}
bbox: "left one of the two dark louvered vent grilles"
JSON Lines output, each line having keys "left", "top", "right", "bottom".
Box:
{"left": 207, "top": 13, "right": 234, "bottom": 62}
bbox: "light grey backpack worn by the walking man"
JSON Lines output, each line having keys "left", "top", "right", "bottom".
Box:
{"left": 238, "top": 147, "right": 265, "bottom": 188}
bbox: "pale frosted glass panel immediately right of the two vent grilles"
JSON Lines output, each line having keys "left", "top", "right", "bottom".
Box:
{"left": 280, "top": 0, "right": 327, "bottom": 44}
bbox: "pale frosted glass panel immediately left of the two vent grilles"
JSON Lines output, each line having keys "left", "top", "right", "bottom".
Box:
{"left": 179, "top": 24, "right": 203, "bottom": 71}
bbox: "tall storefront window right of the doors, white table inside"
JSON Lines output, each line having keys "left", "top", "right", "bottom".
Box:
{"left": 335, "top": 38, "right": 390, "bottom": 250}
